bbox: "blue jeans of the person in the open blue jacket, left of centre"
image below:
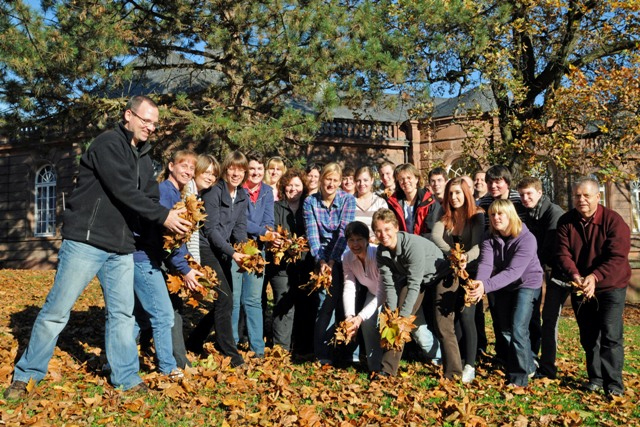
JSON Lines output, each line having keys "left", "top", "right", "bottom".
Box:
{"left": 231, "top": 265, "right": 264, "bottom": 356}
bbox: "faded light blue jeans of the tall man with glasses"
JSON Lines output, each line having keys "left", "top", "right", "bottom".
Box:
{"left": 13, "top": 240, "right": 142, "bottom": 390}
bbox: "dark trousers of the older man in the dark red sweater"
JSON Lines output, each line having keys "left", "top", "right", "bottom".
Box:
{"left": 571, "top": 288, "right": 627, "bottom": 392}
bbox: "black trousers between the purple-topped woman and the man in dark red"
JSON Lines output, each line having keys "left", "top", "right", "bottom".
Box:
{"left": 538, "top": 280, "right": 571, "bottom": 378}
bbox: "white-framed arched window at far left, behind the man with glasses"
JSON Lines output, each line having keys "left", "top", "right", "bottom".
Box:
{"left": 35, "top": 165, "right": 56, "bottom": 236}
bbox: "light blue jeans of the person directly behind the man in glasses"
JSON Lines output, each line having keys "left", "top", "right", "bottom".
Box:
{"left": 133, "top": 259, "right": 177, "bottom": 374}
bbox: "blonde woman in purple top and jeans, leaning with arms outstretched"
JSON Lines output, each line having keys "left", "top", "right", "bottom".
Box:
{"left": 471, "top": 199, "right": 542, "bottom": 387}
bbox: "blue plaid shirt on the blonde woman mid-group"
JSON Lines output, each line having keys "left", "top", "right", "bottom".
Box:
{"left": 303, "top": 190, "right": 356, "bottom": 261}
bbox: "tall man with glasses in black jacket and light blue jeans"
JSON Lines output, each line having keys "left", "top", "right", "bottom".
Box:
{"left": 4, "top": 96, "right": 189, "bottom": 399}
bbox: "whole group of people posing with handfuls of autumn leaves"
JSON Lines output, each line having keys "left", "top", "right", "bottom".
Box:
{"left": 5, "top": 96, "right": 631, "bottom": 398}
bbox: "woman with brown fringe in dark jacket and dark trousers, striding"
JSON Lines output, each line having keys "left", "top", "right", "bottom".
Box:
{"left": 187, "top": 151, "right": 249, "bottom": 366}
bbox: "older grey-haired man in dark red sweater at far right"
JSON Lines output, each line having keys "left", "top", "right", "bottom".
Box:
{"left": 556, "top": 178, "right": 631, "bottom": 397}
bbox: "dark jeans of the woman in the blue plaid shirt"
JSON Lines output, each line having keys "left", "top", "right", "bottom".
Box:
{"left": 313, "top": 262, "right": 344, "bottom": 363}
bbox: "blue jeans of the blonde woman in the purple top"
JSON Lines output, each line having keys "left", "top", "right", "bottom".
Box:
{"left": 493, "top": 288, "right": 541, "bottom": 386}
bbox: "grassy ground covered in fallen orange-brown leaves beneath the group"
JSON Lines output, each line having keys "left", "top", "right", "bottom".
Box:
{"left": 0, "top": 270, "right": 640, "bottom": 426}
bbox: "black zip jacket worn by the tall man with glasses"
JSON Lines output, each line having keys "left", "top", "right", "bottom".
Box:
{"left": 62, "top": 123, "right": 169, "bottom": 254}
